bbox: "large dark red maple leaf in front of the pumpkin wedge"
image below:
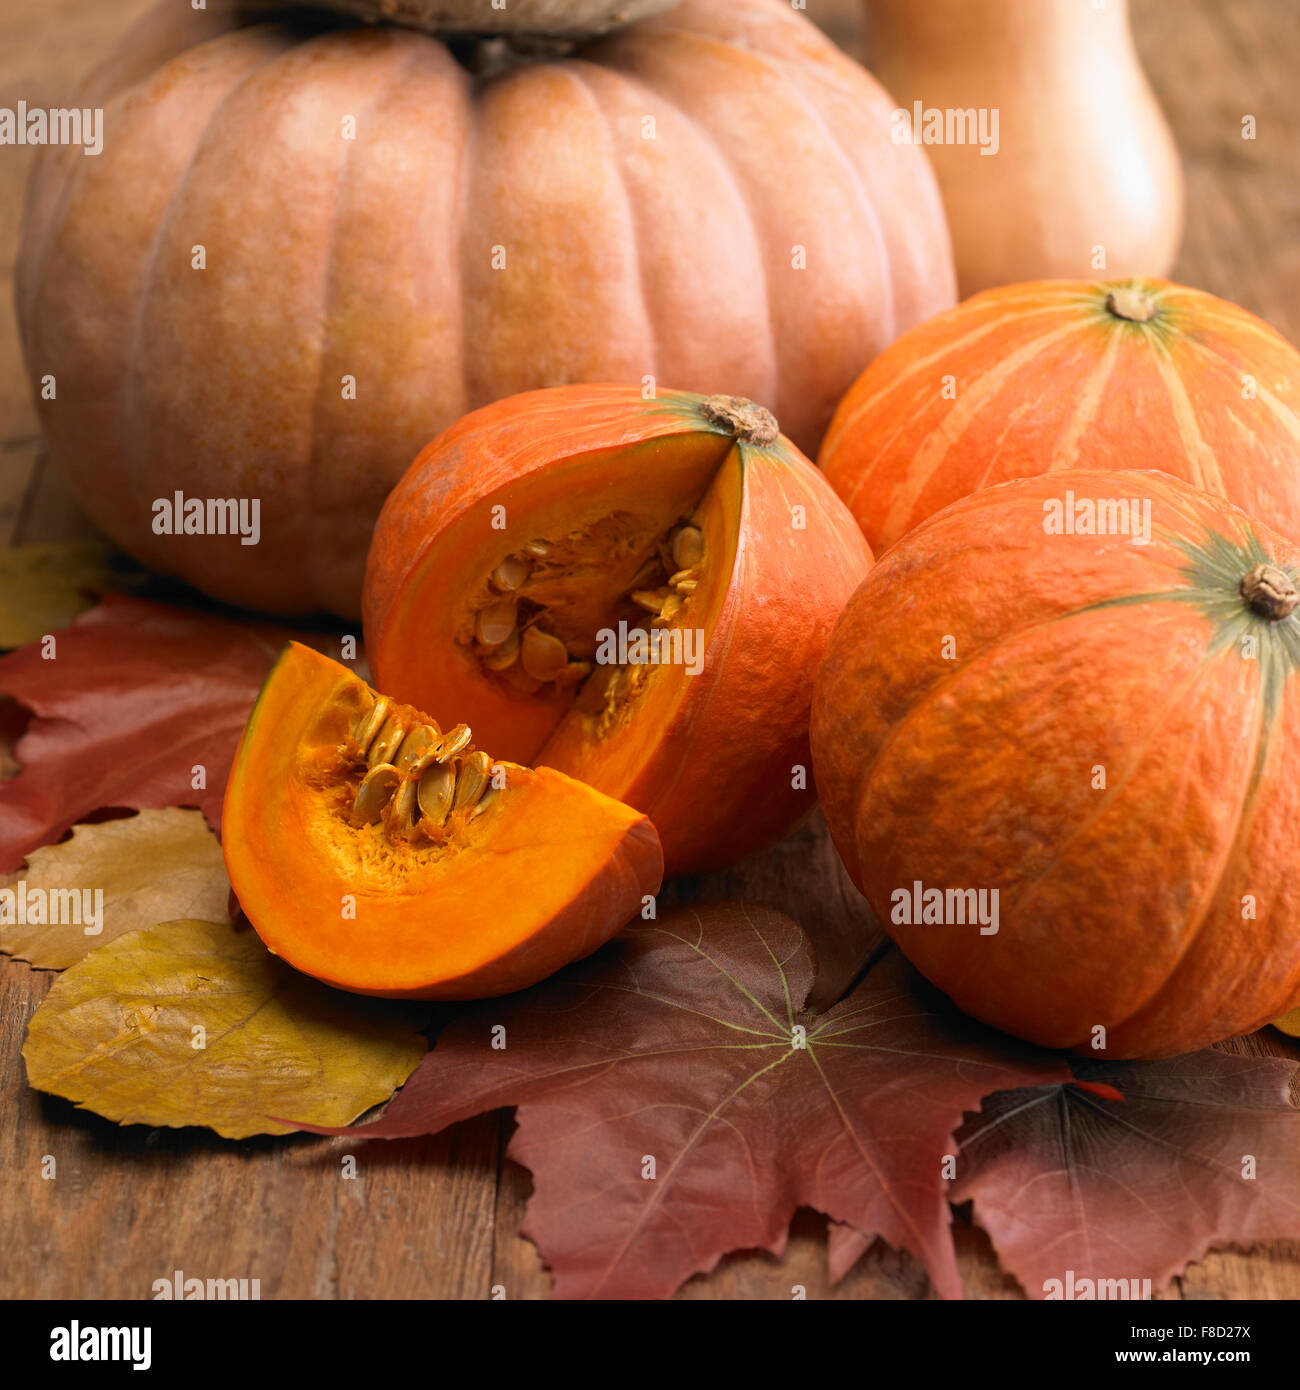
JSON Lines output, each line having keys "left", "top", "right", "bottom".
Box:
{"left": 303, "top": 905, "right": 1065, "bottom": 1298}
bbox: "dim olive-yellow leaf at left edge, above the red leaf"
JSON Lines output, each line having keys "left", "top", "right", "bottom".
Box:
{"left": 0, "top": 541, "right": 143, "bottom": 648}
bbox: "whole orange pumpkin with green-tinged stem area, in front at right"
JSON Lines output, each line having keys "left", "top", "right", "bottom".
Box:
{"left": 812, "top": 473, "right": 1300, "bottom": 1056}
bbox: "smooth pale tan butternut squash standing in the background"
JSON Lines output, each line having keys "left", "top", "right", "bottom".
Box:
{"left": 866, "top": 0, "right": 1185, "bottom": 296}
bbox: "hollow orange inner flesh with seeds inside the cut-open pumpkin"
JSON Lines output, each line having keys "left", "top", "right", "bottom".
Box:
{"left": 369, "top": 422, "right": 744, "bottom": 799}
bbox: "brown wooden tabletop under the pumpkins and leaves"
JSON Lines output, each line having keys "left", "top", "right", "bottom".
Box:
{"left": 0, "top": 0, "right": 1300, "bottom": 1298}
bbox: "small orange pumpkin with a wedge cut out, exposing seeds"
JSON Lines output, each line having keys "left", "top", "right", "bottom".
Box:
{"left": 366, "top": 386, "right": 870, "bottom": 873}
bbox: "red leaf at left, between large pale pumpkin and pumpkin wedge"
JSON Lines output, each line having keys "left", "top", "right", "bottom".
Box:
{"left": 0, "top": 595, "right": 347, "bottom": 870}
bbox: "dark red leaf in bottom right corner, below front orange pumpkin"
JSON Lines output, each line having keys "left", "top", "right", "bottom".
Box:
{"left": 951, "top": 1048, "right": 1300, "bottom": 1298}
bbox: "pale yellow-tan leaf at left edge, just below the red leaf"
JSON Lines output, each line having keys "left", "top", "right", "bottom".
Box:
{"left": 0, "top": 810, "right": 231, "bottom": 970}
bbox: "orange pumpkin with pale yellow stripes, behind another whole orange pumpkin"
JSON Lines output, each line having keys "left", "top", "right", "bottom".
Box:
{"left": 818, "top": 279, "right": 1300, "bottom": 555}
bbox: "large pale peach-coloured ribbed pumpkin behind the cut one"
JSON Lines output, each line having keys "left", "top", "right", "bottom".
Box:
{"left": 17, "top": 0, "right": 955, "bottom": 616}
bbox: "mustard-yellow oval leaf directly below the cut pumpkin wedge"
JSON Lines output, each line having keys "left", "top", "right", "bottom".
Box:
{"left": 22, "top": 922, "right": 424, "bottom": 1138}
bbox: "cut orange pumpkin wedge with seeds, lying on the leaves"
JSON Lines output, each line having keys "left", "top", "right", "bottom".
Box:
{"left": 221, "top": 642, "right": 663, "bottom": 999}
